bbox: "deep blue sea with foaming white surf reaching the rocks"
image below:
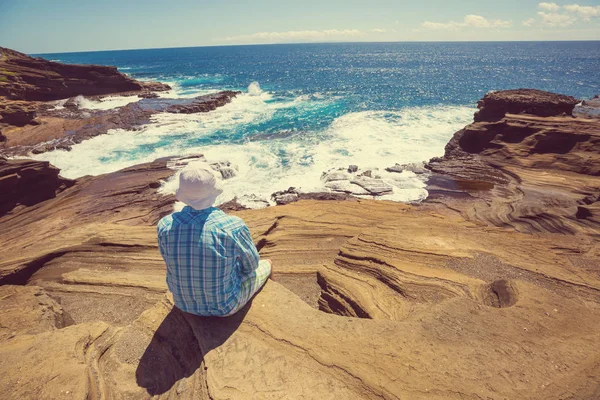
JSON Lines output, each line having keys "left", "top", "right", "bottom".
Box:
{"left": 31, "top": 41, "right": 600, "bottom": 205}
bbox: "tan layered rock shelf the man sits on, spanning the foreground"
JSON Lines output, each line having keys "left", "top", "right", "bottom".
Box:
{"left": 0, "top": 89, "right": 600, "bottom": 399}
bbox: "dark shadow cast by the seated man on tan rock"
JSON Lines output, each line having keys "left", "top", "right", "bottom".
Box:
{"left": 136, "top": 303, "right": 251, "bottom": 396}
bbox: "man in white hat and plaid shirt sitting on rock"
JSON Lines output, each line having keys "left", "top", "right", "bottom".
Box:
{"left": 158, "top": 163, "right": 271, "bottom": 317}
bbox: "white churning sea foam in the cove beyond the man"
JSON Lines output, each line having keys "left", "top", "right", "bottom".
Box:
{"left": 33, "top": 85, "right": 473, "bottom": 206}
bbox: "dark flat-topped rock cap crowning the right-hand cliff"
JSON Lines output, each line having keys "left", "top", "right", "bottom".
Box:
{"left": 475, "top": 89, "right": 579, "bottom": 122}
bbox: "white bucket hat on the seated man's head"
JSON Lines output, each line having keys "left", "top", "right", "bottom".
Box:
{"left": 175, "top": 163, "right": 223, "bottom": 210}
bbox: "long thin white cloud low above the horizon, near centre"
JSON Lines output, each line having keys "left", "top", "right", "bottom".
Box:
{"left": 225, "top": 29, "right": 365, "bottom": 43}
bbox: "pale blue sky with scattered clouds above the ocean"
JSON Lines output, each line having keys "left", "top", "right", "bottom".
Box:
{"left": 0, "top": 0, "right": 600, "bottom": 54}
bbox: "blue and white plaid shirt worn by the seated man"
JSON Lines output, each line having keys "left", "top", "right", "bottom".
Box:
{"left": 158, "top": 206, "right": 259, "bottom": 316}
